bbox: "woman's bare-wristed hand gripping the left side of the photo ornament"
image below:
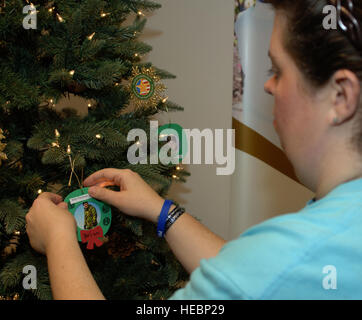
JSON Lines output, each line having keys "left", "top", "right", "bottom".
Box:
{"left": 25, "top": 192, "right": 77, "bottom": 254}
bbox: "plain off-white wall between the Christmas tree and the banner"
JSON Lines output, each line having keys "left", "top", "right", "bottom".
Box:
{"left": 141, "top": 0, "right": 234, "bottom": 238}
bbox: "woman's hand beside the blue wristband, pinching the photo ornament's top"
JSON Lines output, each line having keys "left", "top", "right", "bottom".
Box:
{"left": 84, "top": 168, "right": 164, "bottom": 223}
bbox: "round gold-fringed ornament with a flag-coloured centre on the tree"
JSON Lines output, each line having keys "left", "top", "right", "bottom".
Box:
{"left": 127, "top": 67, "right": 166, "bottom": 108}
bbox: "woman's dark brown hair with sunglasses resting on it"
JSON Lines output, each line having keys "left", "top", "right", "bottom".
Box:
{"left": 264, "top": 0, "right": 362, "bottom": 149}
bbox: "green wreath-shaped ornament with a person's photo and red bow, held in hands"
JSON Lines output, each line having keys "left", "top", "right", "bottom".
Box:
{"left": 64, "top": 188, "right": 112, "bottom": 244}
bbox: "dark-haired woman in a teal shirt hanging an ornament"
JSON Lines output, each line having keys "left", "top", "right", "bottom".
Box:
{"left": 26, "top": 0, "right": 362, "bottom": 299}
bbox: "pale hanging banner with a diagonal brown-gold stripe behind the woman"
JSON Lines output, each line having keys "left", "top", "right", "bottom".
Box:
{"left": 230, "top": 0, "right": 312, "bottom": 237}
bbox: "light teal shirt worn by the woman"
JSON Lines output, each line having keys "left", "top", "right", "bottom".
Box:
{"left": 171, "top": 179, "right": 362, "bottom": 300}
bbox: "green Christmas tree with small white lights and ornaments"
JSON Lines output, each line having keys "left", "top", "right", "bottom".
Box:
{"left": 0, "top": 0, "right": 189, "bottom": 299}
